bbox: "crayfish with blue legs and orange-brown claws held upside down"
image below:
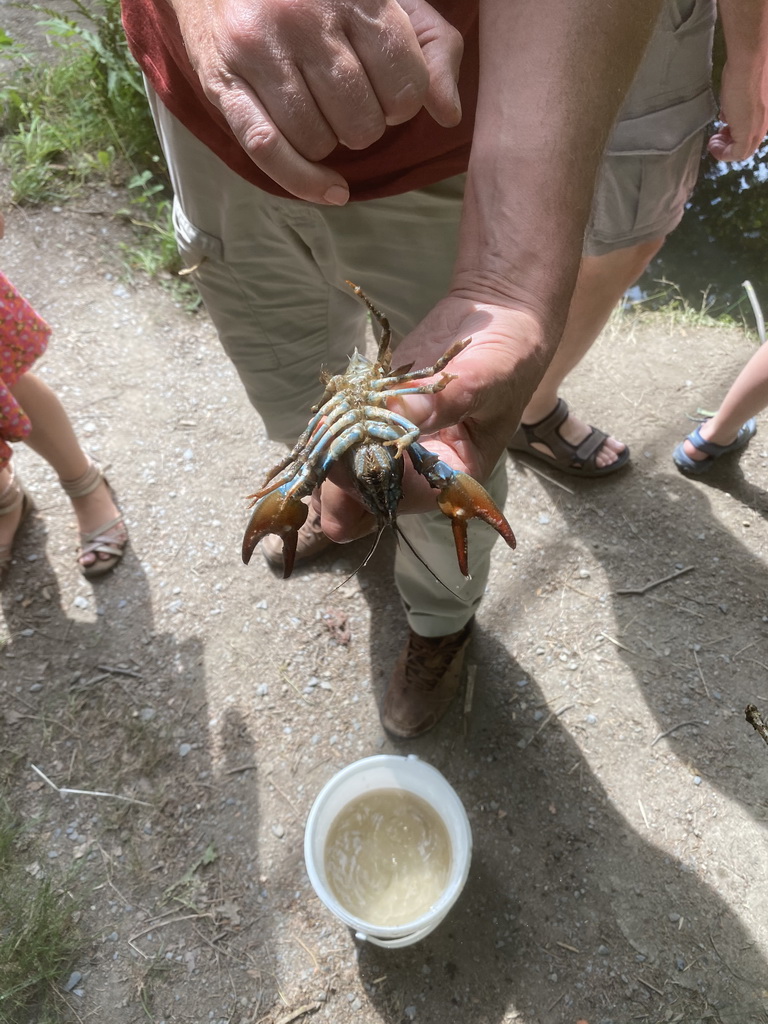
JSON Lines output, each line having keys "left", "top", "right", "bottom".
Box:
{"left": 243, "top": 281, "right": 515, "bottom": 579}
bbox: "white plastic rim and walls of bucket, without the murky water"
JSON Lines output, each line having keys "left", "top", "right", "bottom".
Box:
{"left": 304, "top": 754, "right": 472, "bottom": 949}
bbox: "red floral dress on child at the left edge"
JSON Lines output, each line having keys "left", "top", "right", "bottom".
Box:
{"left": 0, "top": 272, "right": 50, "bottom": 469}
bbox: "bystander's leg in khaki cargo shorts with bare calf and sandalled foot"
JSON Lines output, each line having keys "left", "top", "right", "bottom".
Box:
{"left": 512, "top": 0, "right": 716, "bottom": 469}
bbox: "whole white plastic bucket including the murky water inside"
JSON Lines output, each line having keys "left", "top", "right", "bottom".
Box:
{"left": 304, "top": 755, "right": 472, "bottom": 947}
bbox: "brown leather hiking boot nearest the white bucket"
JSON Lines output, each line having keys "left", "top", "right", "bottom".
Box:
{"left": 380, "top": 620, "right": 473, "bottom": 739}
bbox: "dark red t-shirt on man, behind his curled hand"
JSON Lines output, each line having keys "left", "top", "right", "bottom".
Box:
{"left": 122, "top": 0, "right": 478, "bottom": 200}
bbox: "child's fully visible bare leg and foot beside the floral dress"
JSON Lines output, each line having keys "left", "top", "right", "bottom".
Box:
{"left": 13, "top": 373, "right": 127, "bottom": 565}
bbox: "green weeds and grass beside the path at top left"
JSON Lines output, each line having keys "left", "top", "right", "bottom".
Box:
{"left": 0, "top": 0, "right": 182, "bottom": 273}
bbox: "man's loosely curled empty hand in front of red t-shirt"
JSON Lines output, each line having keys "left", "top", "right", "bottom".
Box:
{"left": 172, "top": 0, "right": 463, "bottom": 206}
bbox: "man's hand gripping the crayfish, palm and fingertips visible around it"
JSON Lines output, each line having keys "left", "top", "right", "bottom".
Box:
{"left": 315, "top": 297, "right": 547, "bottom": 542}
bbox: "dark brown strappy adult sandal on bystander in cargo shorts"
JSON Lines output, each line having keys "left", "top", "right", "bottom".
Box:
{"left": 507, "top": 398, "right": 630, "bottom": 477}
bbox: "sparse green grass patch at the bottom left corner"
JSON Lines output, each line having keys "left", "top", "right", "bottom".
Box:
{"left": 0, "top": 798, "right": 82, "bottom": 1024}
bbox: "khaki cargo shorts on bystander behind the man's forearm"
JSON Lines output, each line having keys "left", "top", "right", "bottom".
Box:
{"left": 584, "top": 0, "right": 717, "bottom": 256}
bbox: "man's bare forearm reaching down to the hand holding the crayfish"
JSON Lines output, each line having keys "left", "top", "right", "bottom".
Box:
{"left": 454, "top": 0, "right": 659, "bottom": 343}
